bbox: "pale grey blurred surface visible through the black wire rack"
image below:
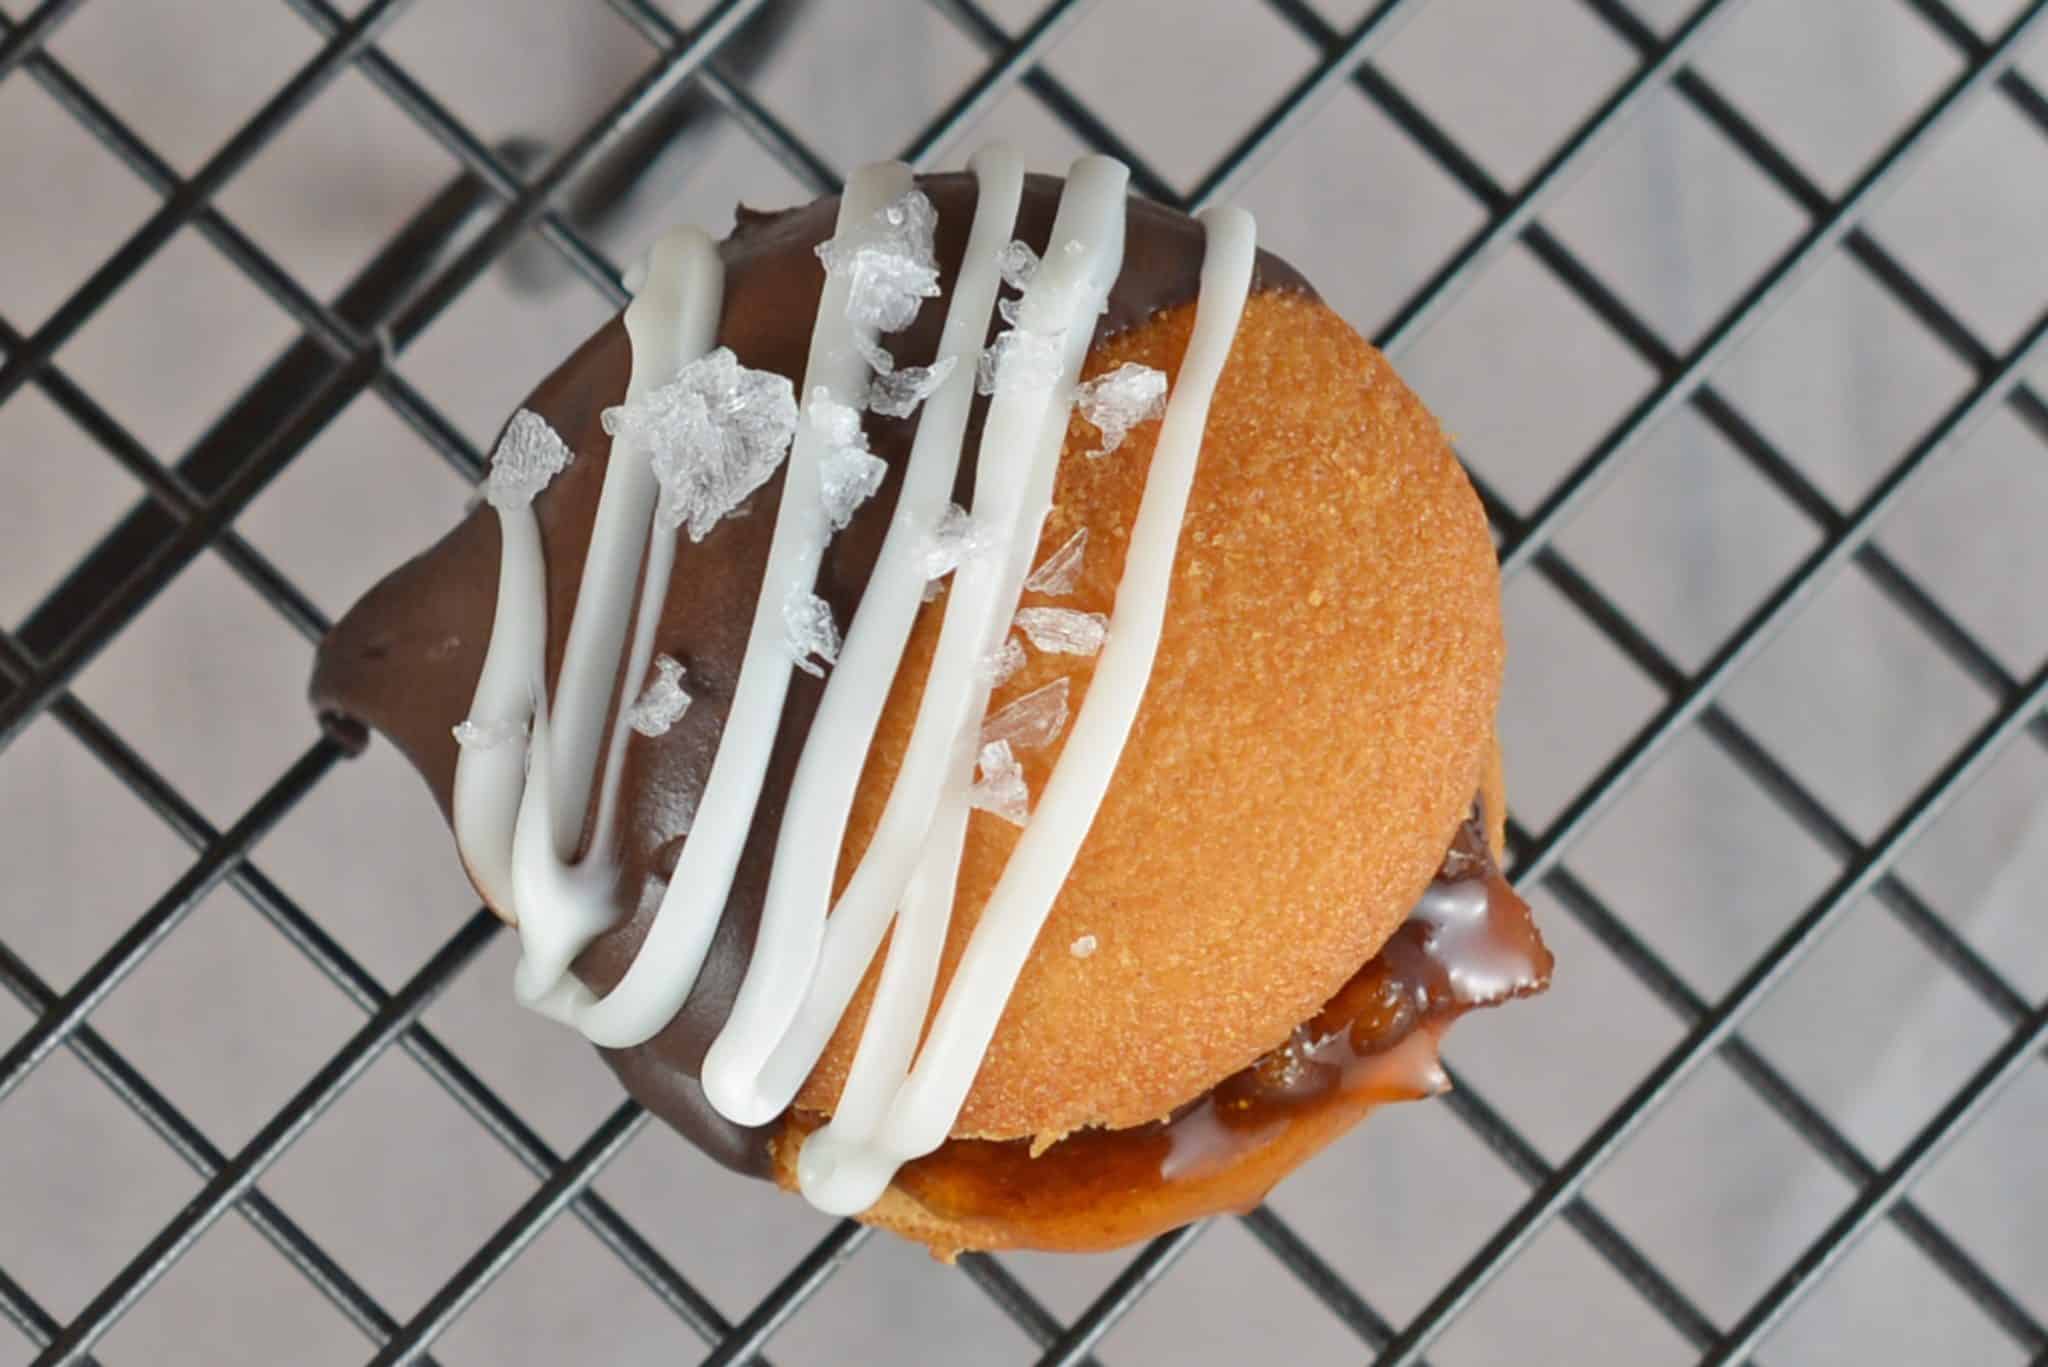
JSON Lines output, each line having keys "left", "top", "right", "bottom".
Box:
{"left": 0, "top": 0, "right": 2048, "bottom": 1365}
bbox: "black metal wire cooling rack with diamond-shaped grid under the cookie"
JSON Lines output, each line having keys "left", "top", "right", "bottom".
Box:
{"left": 0, "top": 0, "right": 2048, "bottom": 1363}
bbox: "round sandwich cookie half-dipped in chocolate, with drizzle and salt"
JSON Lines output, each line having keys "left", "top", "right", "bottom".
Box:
{"left": 313, "top": 148, "right": 1550, "bottom": 1254}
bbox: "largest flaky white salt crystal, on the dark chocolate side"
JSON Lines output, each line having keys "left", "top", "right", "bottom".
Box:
{"left": 602, "top": 346, "right": 797, "bottom": 541}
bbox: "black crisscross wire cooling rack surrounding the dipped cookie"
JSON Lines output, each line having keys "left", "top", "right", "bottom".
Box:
{"left": 0, "top": 0, "right": 2048, "bottom": 1363}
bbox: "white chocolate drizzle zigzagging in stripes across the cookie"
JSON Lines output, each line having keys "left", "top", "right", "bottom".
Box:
{"left": 455, "top": 146, "right": 1255, "bottom": 1213}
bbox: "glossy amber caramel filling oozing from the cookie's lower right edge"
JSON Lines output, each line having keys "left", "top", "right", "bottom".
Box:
{"left": 793, "top": 810, "right": 1550, "bottom": 1248}
